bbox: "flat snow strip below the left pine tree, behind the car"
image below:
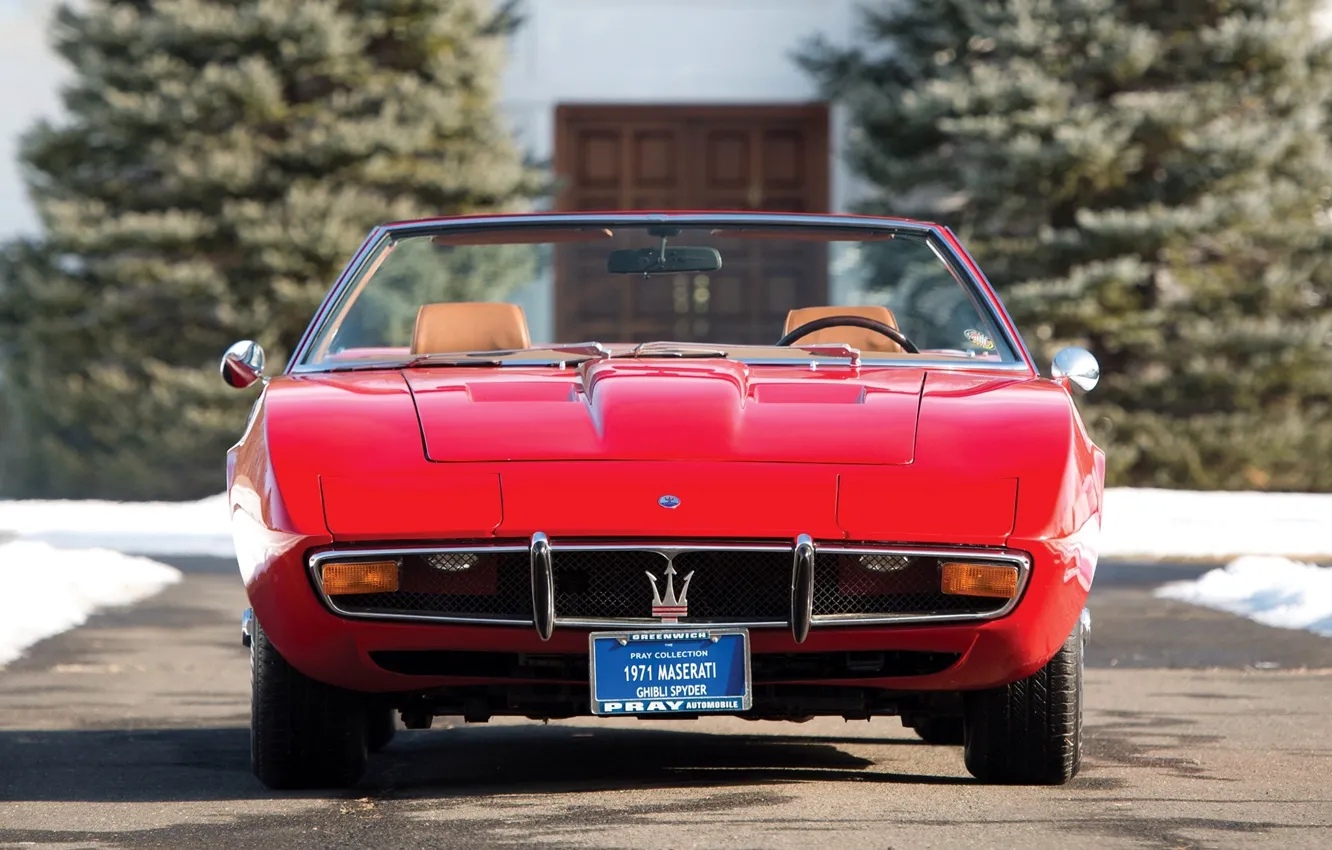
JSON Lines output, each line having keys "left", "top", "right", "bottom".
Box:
{"left": 0, "top": 493, "right": 236, "bottom": 558}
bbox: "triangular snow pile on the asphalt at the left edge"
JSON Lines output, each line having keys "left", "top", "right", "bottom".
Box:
{"left": 0, "top": 540, "right": 180, "bottom": 667}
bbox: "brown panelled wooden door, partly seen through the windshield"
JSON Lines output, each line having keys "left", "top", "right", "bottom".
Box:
{"left": 555, "top": 104, "right": 829, "bottom": 342}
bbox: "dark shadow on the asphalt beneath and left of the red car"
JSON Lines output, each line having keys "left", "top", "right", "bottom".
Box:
{"left": 0, "top": 723, "right": 971, "bottom": 802}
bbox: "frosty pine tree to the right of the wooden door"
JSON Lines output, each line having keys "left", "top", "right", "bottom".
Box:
{"left": 798, "top": 0, "right": 1332, "bottom": 489}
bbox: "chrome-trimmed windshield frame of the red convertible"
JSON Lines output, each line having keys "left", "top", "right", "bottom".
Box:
{"left": 284, "top": 212, "right": 1039, "bottom": 377}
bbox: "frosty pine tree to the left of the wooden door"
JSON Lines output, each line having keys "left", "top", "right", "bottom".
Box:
{"left": 0, "top": 0, "right": 542, "bottom": 498}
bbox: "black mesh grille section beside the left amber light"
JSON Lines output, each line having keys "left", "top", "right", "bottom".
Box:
{"left": 333, "top": 552, "right": 531, "bottom": 621}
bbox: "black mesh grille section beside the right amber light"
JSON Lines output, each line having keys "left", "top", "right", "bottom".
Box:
{"left": 814, "top": 553, "right": 1008, "bottom": 617}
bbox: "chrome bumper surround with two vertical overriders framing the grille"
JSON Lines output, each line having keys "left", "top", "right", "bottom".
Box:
{"left": 309, "top": 532, "right": 1031, "bottom": 643}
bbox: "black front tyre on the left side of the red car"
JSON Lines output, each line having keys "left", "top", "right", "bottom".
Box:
{"left": 250, "top": 621, "right": 368, "bottom": 789}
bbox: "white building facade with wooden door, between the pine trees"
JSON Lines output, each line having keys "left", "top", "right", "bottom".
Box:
{"left": 501, "top": 0, "right": 858, "bottom": 340}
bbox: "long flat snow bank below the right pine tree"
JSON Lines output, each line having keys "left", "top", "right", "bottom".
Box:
{"left": 1100, "top": 488, "right": 1332, "bottom": 561}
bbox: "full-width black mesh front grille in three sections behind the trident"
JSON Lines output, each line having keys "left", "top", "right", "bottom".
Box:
{"left": 314, "top": 544, "right": 1010, "bottom": 625}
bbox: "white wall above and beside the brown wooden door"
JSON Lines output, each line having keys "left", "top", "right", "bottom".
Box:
{"left": 502, "top": 0, "right": 856, "bottom": 209}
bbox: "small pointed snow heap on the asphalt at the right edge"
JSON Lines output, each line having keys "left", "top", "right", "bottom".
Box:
{"left": 1156, "top": 556, "right": 1332, "bottom": 637}
